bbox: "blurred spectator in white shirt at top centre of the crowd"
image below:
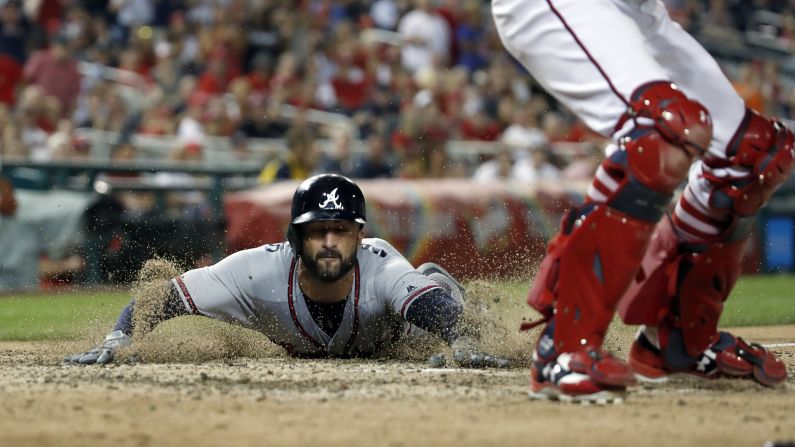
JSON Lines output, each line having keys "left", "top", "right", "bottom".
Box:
{"left": 398, "top": 0, "right": 450, "bottom": 72}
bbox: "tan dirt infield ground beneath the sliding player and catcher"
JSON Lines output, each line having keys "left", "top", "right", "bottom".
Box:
{"left": 0, "top": 326, "right": 795, "bottom": 447}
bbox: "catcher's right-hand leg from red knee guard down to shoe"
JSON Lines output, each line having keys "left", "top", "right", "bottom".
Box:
{"left": 619, "top": 110, "right": 795, "bottom": 385}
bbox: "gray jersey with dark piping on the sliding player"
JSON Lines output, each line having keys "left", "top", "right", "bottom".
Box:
{"left": 172, "top": 238, "right": 441, "bottom": 357}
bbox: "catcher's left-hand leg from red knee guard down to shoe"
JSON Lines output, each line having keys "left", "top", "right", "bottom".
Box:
{"left": 528, "top": 82, "right": 712, "bottom": 402}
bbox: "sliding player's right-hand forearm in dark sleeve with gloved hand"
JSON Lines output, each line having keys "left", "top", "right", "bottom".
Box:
{"left": 406, "top": 289, "right": 510, "bottom": 368}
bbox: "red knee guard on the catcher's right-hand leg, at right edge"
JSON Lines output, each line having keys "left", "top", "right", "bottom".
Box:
{"left": 704, "top": 109, "right": 795, "bottom": 216}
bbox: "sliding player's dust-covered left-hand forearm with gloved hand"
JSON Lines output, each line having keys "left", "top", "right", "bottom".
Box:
{"left": 64, "top": 281, "right": 188, "bottom": 365}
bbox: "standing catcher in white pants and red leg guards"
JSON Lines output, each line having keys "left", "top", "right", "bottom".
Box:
{"left": 492, "top": 0, "right": 795, "bottom": 401}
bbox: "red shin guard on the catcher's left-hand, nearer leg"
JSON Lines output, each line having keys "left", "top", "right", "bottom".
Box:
{"left": 528, "top": 204, "right": 654, "bottom": 352}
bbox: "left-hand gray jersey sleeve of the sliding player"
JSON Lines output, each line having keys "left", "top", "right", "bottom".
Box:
{"left": 172, "top": 250, "right": 258, "bottom": 329}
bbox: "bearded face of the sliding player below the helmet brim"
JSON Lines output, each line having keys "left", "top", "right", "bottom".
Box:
{"left": 301, "top": 221, "right": 360, "bottom": 282}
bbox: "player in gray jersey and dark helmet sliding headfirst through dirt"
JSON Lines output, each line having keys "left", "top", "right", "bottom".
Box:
{"left": 66, "top": 174, "right": 507, "bottom": 367}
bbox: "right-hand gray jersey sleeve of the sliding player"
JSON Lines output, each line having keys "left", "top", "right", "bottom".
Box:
{"left": 367, "top": 239, "right": 444, "bottom": 318}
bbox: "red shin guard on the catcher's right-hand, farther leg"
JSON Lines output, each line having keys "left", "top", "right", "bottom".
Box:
{"left": 618, "top": 215, "right": 752, "bottom": 358}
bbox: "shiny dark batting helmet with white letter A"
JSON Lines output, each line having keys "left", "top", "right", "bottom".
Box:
{"left": 287, "top": 174, "right": 367, "bottom": 254}
